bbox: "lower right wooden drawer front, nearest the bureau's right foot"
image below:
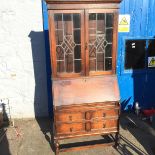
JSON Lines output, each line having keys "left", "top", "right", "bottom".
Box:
{"left": 91, "top": 120, "right": 118, "bottom": 130}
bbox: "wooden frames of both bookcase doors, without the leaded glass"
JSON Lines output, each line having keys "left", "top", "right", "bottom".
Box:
{"left": 48, "top": 9, "right": 118, "bottom": 78}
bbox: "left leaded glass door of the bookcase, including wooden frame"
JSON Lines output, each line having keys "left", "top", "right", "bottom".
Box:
{"left": 49, "top": 10, "right": 85, "bottom": 77}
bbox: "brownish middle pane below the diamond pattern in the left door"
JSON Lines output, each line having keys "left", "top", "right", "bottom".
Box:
{"left": 65, "top": 54, "right": 73, "bottom": 73}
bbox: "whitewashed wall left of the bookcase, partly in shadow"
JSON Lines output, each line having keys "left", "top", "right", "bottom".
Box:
{"left": 0, "top": 0, "right": 48, "bottom": 118}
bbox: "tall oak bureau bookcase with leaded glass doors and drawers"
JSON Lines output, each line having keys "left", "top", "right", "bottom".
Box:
{"left": 46, "top": 0, "right": 121, "bottom": 154}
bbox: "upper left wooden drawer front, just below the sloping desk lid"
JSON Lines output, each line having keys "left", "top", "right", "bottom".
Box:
{"left": 55, "top": 111, "right": 85, "bottom": 122}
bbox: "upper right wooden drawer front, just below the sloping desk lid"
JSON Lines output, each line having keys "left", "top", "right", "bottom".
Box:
{"left": 92, "top": 109, "right": 119, "bottom": 118}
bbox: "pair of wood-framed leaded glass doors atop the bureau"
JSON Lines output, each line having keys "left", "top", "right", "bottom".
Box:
{"left": 49, "top": 9, "right": 118, "bottom": 77}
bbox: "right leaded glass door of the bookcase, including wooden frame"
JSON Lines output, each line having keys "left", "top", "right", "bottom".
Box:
{"left": 86, "top": 9, "right": 117, "bottom": 75}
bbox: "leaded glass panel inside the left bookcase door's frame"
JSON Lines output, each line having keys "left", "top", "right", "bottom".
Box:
{"left": 54, "top": 13, "right": 81, "bottom": 73}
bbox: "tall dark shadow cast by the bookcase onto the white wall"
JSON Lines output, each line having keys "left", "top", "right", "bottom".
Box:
{"left": 28, "top": 31, "right": 54, "bottom": 150}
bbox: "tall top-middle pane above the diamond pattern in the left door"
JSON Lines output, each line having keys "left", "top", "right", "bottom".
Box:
{"left": 63, "top": 14, "right": 73, "bottom": 35}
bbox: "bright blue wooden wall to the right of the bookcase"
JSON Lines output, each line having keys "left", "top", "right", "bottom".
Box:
{"left": 117, "top": 0, "right": 155, "bottom": 110}
